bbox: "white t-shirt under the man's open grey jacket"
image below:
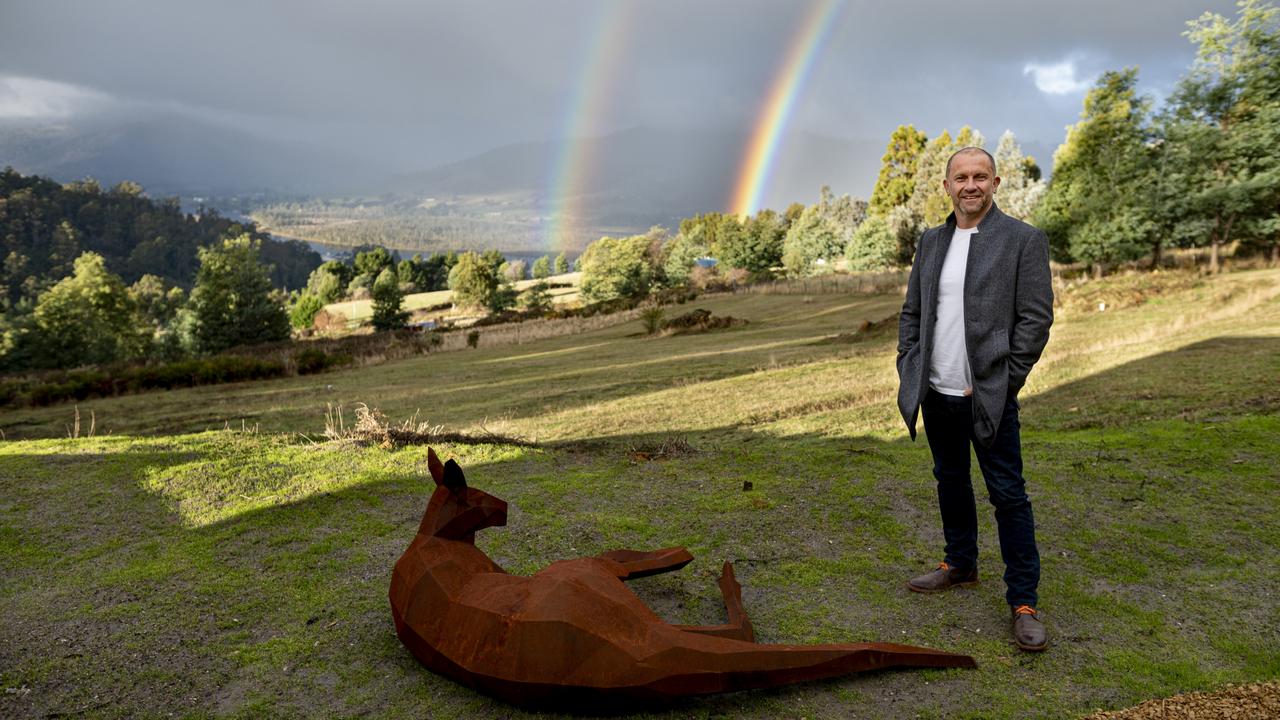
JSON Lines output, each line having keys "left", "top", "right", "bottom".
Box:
{"left": 929, "top": 228, "right": 978, "bottom": 396}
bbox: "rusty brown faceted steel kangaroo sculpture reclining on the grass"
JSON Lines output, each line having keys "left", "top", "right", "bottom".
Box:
{"left": 390, "top": 451, "right": 975, "bottom": 711}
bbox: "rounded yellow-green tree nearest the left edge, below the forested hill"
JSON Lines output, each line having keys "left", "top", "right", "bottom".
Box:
{"left": 31, "top": 252, "right": 150, "bottom": 368}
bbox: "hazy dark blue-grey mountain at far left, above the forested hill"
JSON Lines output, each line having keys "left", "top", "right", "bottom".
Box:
{"left": 0, "top": 113, "right": 376, "bottom": 196}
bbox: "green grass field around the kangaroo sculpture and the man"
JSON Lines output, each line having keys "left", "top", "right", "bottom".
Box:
{"left": 0, "top": 270, "right": 1280, "bottom": 719}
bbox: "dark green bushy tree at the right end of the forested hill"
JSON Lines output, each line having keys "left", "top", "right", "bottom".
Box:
{"left": 189, "top": 234, "right": 289, "bottom": 354}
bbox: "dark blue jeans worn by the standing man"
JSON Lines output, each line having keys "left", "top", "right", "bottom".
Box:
{"left": 922, "top": 389, "right": 1039, "bottom": 607}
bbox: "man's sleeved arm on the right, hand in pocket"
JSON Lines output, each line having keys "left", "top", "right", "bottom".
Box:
{"left": 1009, "top": 229, "right": 1053, "bottom": 392}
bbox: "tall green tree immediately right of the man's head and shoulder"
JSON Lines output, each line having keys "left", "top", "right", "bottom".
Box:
{"left": 1036, "top": 68, "right": 1153, "bottom": 275}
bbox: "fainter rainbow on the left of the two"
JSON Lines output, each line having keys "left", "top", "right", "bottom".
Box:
{"left": 543, "top": 0, "right": 626, "bottom": 252}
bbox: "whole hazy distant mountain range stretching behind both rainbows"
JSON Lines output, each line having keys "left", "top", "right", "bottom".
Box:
{"left": 0, "top": 114, "right": 1050, "bottom": 235}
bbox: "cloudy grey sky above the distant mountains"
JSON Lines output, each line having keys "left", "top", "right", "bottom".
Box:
{"left": 0, "top": 0, "right": 1234, "bottom": 178}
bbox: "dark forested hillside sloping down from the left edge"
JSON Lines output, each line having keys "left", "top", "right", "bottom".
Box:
{"left": 0, "top": 168, "right": 321, "bottom": 302}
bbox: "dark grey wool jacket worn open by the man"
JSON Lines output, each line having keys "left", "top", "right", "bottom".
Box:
{"left": 897, "top": 204, "right": 1053, "bottom": 446}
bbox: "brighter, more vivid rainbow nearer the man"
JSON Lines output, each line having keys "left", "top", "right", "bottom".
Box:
{"left": 730, "top": 0, "right": 845, "bottom": 215}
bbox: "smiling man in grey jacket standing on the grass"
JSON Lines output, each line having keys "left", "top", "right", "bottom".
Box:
{"left": 897, "top": 147, "right": 1053, "bottom": 651}
